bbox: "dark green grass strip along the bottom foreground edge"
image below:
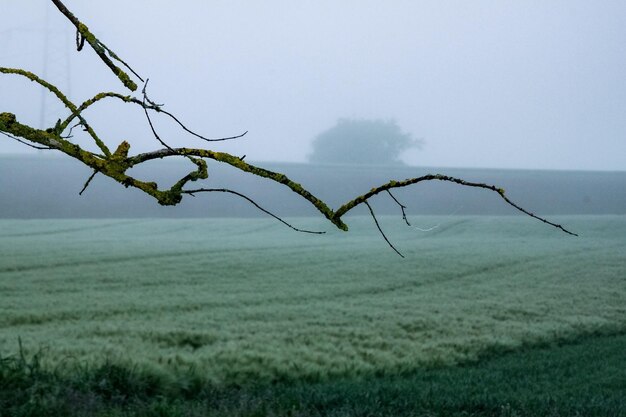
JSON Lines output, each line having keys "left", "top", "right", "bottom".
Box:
{"left": 0, "top": 335, "right": 626, "bottom": 417}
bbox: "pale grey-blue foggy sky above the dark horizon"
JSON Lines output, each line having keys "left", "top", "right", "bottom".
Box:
{"left": 0, "top": 0, "right": 626, "bottom": 170}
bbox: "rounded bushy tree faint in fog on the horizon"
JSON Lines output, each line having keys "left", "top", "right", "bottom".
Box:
{"left": 309, "top": 119, "right": 422, "bottom": 165}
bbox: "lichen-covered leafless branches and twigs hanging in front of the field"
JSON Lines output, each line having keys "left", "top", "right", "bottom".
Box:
{"left": 0, "top": 0, "right": 577, "bottom": 256}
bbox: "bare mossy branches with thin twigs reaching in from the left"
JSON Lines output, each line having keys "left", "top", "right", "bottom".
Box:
{"left": 0, "top": 0, "right": 574, "bottom": 256}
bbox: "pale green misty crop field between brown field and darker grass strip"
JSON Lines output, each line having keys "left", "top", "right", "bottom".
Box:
{"left": 0, "top": 216, "right": 626, "bottom": 415}
